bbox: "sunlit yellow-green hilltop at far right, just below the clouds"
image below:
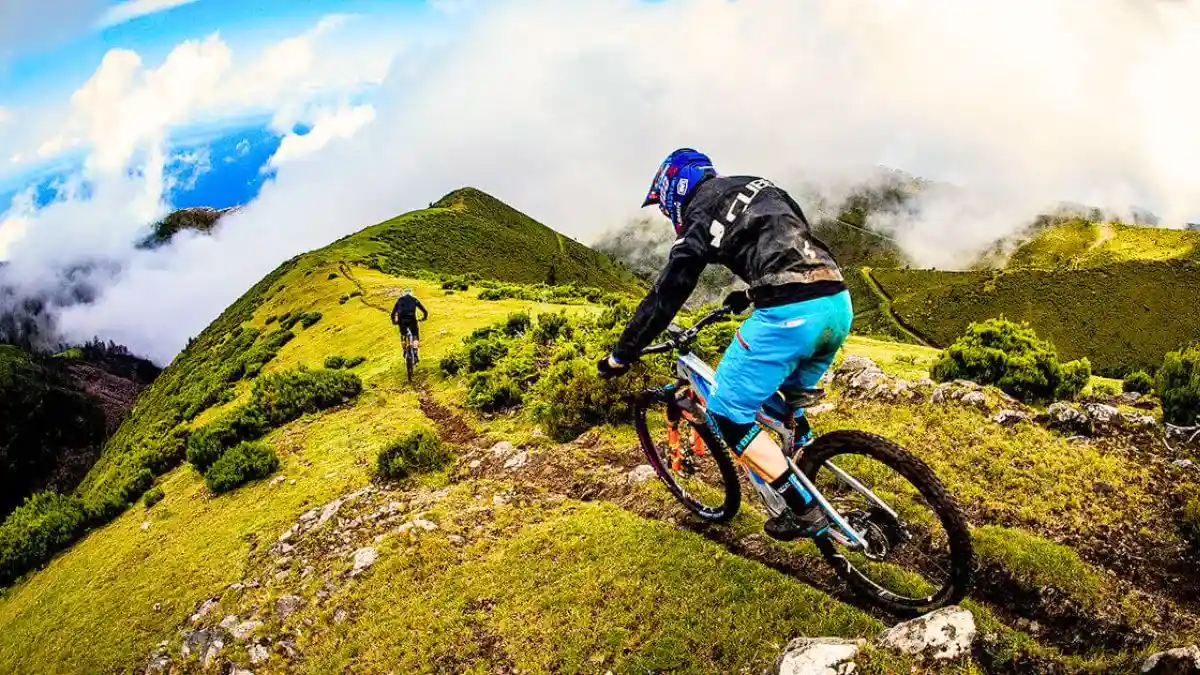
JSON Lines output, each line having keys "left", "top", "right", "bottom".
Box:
{"left": 1008, "top": 220, "right": 1200, "bottom": 269}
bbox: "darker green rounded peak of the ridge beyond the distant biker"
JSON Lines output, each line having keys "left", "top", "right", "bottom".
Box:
{"left": 316, "top": 187, "right": 640, "bottom": 291}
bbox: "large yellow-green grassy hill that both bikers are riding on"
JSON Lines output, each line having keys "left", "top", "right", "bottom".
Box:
{"left": 0, "top": 191, "right": 1200, "bottom": 674}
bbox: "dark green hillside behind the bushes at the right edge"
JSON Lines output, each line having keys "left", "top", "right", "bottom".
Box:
{"left": 874, "top": 261, "right": 1200, "bottom": 375}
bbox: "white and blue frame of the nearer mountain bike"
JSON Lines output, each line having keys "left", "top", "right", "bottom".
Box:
{"left": 668, "top": 352, "right": 878, "bottom": 549}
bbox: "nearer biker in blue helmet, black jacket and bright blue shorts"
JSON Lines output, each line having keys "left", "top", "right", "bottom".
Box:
{"left": 598, "top": 148, "right": 853, "bottom": 540}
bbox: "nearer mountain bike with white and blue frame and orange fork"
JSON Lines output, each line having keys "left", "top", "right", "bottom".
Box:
{"left": 631, "top": 306, "right": 974, "bottom": 616}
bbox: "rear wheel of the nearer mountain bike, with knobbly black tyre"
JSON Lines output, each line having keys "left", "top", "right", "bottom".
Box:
{"left": 797, "top": 431, "right": 974, "bottom": 616}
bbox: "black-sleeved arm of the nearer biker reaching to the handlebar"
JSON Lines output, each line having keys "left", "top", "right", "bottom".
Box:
{"left": 612, "top": 219, "right": 708, "bottom": 364}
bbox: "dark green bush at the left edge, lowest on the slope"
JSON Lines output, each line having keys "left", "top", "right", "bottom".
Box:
{"left": 0, "top": 491, "right": 85, "bottom": 586}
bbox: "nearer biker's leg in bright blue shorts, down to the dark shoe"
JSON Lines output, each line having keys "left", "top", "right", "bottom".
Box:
{"left": 708, "top": 293, "right": 851, "bottom": 538}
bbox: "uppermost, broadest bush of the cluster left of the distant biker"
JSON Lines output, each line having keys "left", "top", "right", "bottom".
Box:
{"left": 251, "top": 368, "right": 362, "bottom": 426}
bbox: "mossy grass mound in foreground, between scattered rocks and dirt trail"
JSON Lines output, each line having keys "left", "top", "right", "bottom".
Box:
{"left": 296, "top": 492, "right": 882, "bottom": 673}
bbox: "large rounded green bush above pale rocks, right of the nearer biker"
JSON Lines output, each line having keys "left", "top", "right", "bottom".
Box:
{"left": 930, "top": 318, "right": 1091, "bottom": 402}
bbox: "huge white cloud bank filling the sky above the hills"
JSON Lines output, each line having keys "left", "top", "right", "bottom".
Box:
{"left": 2, "top": 0, "right": 1200, "bottom": 360}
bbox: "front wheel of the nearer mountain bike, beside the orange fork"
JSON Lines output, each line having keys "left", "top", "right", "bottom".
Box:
{"left": 634, "top": 389, "right": 742, "bottom": 522}
